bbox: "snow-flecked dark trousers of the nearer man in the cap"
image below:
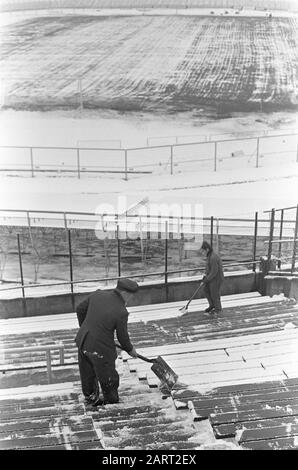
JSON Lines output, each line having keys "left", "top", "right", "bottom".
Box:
{"left": 78, "top": 348, "right": 119, "bottom": 403}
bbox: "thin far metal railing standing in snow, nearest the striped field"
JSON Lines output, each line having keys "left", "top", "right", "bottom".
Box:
{"left": 0, "top": 133, "right": 298, "bottom": 180}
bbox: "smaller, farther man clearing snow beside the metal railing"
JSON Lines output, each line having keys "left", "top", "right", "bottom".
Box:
{"left": 201, "top": 241, "right": 224, "bottom": 314}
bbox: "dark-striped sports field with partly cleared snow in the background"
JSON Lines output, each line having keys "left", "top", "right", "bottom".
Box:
{"left": 0, "top": 15, "right": 298, "bottom": 113}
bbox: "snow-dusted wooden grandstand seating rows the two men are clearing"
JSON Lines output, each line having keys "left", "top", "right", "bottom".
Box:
{"left": 0, "top": 292, "right": 298, "bottom": 449}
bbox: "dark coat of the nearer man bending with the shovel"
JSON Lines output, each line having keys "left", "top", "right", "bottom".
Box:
{"left": 75, "top": 289, "right": 133, "bottom": 360}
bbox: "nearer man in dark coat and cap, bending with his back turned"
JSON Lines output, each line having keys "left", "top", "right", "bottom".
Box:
{"left": 75, "top": 279, "right": 138, "bottom": 406}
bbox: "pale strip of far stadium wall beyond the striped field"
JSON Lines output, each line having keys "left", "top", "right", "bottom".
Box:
{"left": 0, "top": 0, "right": 298, "bottom": 12}
